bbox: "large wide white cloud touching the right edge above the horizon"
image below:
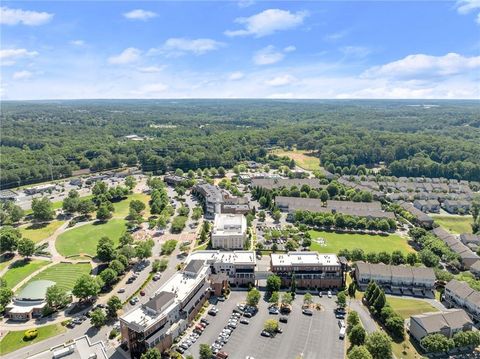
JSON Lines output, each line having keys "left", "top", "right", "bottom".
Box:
{"left": 362, "top": 53, "right": 480, "bottom": 79}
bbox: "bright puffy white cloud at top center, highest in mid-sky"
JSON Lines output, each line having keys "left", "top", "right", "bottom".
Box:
{"left": 225, "top": 9, "right": 308, "bottom": 37}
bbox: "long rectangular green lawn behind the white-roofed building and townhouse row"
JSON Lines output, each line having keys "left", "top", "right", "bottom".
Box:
{"left": 309, "top": 230, "right": 414, "bottom": 253}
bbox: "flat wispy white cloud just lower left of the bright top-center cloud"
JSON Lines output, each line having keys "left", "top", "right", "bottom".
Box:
{"left": 158, "top": 38, "right": 225, "bottom": 56}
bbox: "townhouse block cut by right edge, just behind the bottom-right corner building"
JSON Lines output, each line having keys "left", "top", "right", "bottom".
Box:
{"left": 443, "top": 279, "right": 480, "bottom": 322}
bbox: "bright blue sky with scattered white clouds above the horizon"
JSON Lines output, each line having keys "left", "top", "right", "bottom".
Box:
{"left": 0, "top": 0, "right": 480, "bottom": 100}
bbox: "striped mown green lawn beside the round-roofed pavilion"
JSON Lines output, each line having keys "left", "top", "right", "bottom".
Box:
{"left": 19, "top": 263, "right": 92, "bottom": 291}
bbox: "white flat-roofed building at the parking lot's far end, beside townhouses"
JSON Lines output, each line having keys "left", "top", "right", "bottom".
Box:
{"left": 270, "top": 252, "right": 346, "bottom": 289}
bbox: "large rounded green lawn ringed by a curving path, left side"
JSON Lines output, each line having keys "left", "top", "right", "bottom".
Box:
{"left": 55, "top": 219, "right": 126, "bottom": 256}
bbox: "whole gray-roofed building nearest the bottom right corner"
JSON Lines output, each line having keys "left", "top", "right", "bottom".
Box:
{"left": 410, "top": 309, "right": 473, "bottom": 342}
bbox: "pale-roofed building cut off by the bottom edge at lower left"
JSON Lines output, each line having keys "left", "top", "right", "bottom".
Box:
{"left": 30, "top": 335, "right": 108, "bottom": 359}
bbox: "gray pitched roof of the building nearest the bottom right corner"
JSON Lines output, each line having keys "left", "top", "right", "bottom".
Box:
{"left": 411, "top": 309, "right": 473, "bottom": 334}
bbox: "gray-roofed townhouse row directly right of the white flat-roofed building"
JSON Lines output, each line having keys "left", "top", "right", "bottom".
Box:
{"left": 353, "top": 261, "right": 435, "bottom": 297}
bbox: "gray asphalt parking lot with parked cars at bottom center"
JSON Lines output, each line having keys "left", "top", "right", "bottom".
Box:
{"left": 184, "top": 291, "right": 344, "bottom": 359}
